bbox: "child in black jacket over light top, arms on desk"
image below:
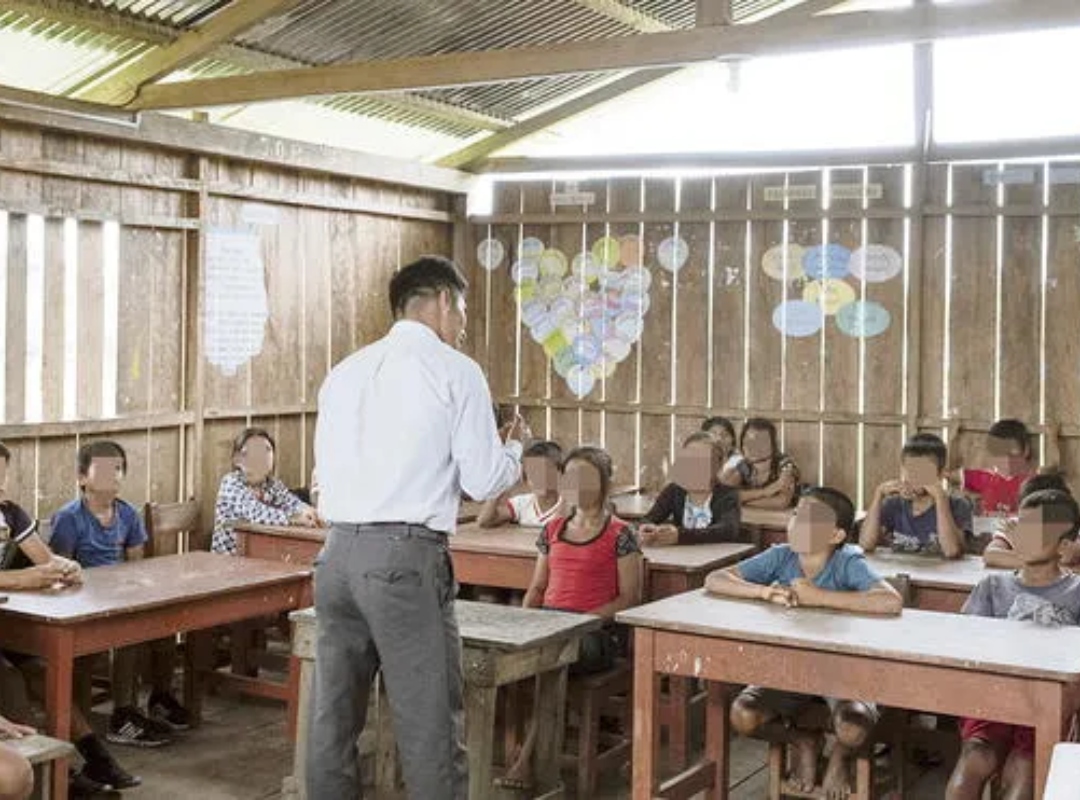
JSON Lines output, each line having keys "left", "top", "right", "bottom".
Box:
{"left": 637, "top": 431, "right": 750, "bottom": 547}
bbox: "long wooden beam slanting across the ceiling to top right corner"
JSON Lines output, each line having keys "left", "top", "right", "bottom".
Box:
{"left": 131, "top": 0, "right": 1080, "bottom": 109}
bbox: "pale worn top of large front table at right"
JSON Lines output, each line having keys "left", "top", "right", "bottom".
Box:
{"left": 616, "top": 591, "right": 1080, "bottom": 683}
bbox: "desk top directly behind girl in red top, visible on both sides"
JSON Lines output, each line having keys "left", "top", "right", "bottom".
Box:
{"left": 449, "top": 524, "right": 756, "bottom": 572}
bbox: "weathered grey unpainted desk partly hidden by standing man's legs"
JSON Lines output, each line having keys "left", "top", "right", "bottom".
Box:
{"left": 289, "top": 600, "right": 600, "bottom": 800}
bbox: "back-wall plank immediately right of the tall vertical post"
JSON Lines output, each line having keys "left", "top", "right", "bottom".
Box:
{"left": 948, "top": 165, "right": 997, "bottom": 419}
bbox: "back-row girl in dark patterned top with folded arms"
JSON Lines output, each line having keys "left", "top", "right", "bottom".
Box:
{"left": 720, "top": 417, "right": 799, "bottom": 509}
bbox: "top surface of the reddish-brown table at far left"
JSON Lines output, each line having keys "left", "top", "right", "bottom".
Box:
{"left": 0, "top": 553, "right": 311, "bottom": 625}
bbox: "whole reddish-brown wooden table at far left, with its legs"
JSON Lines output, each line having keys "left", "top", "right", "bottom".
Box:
{"left": 0, "top": 553, "right": 311, "bottom": 797}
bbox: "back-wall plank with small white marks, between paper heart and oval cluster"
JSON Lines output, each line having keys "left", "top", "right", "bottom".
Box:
{"left": 712, "top": 175, "right": 747, "bottom": 408}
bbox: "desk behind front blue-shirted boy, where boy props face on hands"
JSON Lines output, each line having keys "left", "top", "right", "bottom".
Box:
{"left": 866, "top": 550, "right": 1002, "bottom": 614}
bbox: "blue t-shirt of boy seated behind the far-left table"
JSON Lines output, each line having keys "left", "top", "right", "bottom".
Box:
{"left": 49, "top": 499, "right": 146, "bottom": 568}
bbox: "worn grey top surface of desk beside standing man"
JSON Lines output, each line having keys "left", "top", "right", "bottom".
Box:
{"left": 289, "top": 600, "right": 603, "bottom": 651}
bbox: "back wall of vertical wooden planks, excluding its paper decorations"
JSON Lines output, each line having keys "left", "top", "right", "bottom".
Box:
{"left": 473, "top": 162, "right": 1080, "bottom": 505}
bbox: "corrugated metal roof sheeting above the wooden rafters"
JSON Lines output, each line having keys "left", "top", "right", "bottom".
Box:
{"left": 0, "top": 0, "right": 789, "bottom": 160}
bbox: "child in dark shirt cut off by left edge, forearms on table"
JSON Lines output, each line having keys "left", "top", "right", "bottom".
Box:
{"left": 0, "top": 444, "right": 141, "bottom": 798}
